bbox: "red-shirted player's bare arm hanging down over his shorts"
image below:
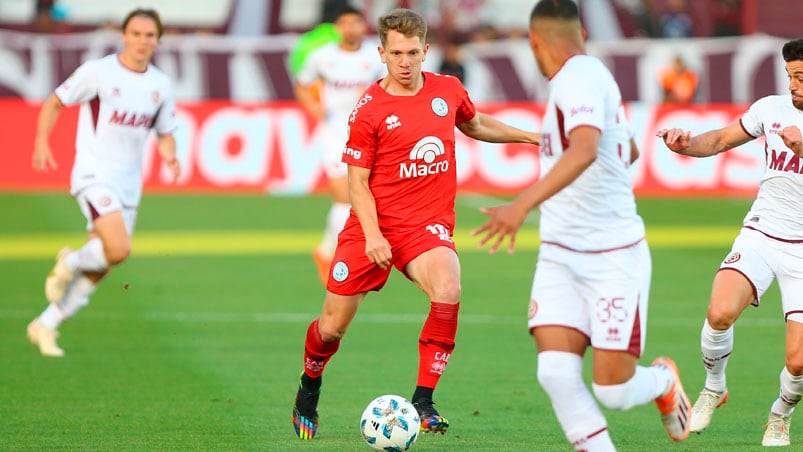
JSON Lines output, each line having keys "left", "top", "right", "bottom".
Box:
{"left": 348, "top": 165, "right": 392, "bottom": 269}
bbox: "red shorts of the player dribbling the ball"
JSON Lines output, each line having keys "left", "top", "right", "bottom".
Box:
{"left": 326, "top": 221, "right": 457, "bottom": 296}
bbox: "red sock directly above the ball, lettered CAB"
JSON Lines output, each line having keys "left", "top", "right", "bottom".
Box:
{"left": 416, "top": 301, "right": 460, "bottom": 389}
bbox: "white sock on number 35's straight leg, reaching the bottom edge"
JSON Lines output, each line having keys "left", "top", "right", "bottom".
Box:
{"left": 538, "top": 351, "right": 616, "bottom": 452}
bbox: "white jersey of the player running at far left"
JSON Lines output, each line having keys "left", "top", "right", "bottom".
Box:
{"left": 55, "top": 55, "right": 176, "bottom": 207}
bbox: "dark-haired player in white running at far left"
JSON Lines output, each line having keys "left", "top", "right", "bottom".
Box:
{"left": 28, "top": 9, "right": 180, "bottom": 356}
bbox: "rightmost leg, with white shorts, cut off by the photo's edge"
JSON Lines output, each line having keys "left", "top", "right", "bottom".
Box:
{"left": 761, "top": 256, "right": 803, "bottom": 446}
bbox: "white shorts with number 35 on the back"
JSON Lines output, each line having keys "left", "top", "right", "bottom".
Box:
{"left": 528, "top": 240, "right": 652, "bottom": 357}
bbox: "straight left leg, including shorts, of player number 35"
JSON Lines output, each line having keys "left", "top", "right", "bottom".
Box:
{"left": 528, "top": 244, "right": 615, "bottom": 451}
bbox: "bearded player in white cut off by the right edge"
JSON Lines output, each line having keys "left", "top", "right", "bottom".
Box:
{"left": 657, "top": 39, "right": 803, "bottom": 446}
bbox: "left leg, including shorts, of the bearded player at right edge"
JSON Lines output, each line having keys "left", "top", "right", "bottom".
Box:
{"left": 691, "top": 230, "right": 774, "bottom": 432}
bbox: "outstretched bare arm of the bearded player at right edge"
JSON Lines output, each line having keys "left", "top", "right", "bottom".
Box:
{"left": 655, "top": 121, "right": 754, "bottom": 157}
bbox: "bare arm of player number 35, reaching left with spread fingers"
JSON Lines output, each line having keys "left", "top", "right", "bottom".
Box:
{"left": 472, "top": 126, "right": 600, "bottom": 253}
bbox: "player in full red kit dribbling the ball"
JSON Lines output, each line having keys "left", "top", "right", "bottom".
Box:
{"left": 292, "top": 9, "right": 538, "bottom": 439}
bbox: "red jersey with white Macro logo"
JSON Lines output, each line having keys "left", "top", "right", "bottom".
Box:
{"left": 342, "top": 72, "right": 477, "bottom": 232}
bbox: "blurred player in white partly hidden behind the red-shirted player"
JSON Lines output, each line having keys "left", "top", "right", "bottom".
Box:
{"left": 295, "top": 6, "right": 385, "bottom": 284}
